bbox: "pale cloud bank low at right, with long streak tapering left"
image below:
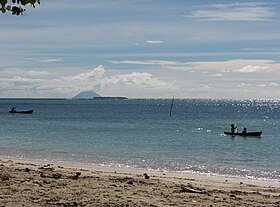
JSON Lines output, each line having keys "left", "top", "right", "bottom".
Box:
{"left": 107, "top": 59, "right": 280, "bottom": 98}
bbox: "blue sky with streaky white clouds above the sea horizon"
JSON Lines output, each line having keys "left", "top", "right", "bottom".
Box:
{"left": 0, "top": 0, "right": 280, "bottom": 99}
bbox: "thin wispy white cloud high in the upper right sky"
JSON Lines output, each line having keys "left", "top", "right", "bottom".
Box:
{"left": 183, "top": 2, "right": 276, "bottom": 21}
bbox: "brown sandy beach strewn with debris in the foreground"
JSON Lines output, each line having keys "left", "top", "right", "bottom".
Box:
{"left": 0, "top": 159, "right": 280, "bottom": 207}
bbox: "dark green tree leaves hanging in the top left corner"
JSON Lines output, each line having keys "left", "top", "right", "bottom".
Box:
{"left": 0, "top": 0, "right": 40, "bottom": 15}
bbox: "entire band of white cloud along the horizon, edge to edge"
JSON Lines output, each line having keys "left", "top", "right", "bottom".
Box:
{"left": 0, "top": 60, "right": 280, "bottom": 98}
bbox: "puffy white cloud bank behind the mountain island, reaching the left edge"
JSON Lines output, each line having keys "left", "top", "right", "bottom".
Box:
{"left": 0, "top": 65, "right": 176, "bottom": 97}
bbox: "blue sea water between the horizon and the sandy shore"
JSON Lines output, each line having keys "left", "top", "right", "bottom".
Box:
{"left": 0, "top": 99, "right": 280, "bottom": 181}
